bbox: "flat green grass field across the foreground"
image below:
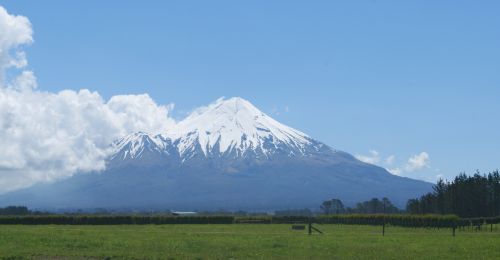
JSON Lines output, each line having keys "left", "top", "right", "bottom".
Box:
{"left": 0, "top": 224, "right": 500, "bottom": 259}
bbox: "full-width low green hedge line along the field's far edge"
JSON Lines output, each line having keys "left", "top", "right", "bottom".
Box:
{"left": 0, "top": 214, "right": 470, "bottom": 228}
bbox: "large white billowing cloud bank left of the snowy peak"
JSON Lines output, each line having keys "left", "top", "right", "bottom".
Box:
{"left": 0, "top": 6, "right": 175, "bottom": 193}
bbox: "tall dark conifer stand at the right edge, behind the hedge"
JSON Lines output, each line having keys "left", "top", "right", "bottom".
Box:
{"left": 406, "top": 170, "right": 500, "bottom": 218}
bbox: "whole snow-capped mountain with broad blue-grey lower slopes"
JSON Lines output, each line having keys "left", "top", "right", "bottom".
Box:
{"left": 0, "top": 98, "right": 432, "bottom": 211}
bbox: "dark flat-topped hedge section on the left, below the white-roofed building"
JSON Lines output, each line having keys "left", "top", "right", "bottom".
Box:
{"left": 0, "top": 215, "right": 234, "bottom": 225}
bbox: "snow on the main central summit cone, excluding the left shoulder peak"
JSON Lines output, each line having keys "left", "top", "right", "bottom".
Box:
{"left": 166, "top": 98, "right": 311, "bottom": 156}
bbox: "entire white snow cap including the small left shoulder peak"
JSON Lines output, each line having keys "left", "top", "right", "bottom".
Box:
{"left": 110, "top": 98, "right": 334, "bottom": 162}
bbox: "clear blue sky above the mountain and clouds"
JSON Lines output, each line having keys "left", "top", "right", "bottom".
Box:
{"left": 0, "top": 0, "right": 500, "bottom": 180}
